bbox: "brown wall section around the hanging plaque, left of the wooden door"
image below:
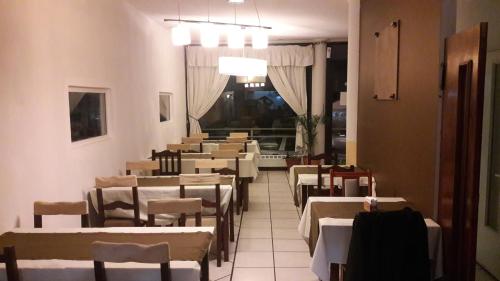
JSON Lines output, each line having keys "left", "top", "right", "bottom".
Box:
{"left": 357, "top": 0, "right": 441, "bottom": 216}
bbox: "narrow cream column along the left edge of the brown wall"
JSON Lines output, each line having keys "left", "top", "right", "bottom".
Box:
{"left": 346, "top": 0, "right": 360, "bottom": 165}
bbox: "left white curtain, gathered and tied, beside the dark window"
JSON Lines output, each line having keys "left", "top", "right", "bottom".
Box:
{"left": 187, "top": 66, "right": 229, "bottom": 134}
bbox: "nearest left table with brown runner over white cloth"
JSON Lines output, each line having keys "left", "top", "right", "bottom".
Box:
{"left": 0, "top": 227, "right": 214, "bottom": 281}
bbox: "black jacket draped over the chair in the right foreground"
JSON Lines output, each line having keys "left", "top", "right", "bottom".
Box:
{"left": 345, "top": 208, "right": 430, "bottom": 281}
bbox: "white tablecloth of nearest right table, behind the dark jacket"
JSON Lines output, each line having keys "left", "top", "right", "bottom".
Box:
{"left": 311, "top": 218, "right": 443, "bottom": 280}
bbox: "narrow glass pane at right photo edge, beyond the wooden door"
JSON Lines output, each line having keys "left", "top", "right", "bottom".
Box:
{"left": 487, "top": 64, "right": 500, "bottom": 230}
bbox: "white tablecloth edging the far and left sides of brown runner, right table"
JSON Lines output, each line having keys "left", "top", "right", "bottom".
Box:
{"left": 298, "top": 196, "right": 406, "bottom": 241}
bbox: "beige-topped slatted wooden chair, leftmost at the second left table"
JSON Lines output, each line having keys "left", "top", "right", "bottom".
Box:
{"left": 95, "top": 175, "right": 142, "bottom": 227}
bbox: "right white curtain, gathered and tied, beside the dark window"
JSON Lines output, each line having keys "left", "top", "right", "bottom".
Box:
{"left": 267, "top": 66, "right": 307, "bottom": 148}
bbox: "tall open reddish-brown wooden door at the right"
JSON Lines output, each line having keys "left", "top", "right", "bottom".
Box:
{"left": 438, "top": 23, "right": 487, "bottom": 281}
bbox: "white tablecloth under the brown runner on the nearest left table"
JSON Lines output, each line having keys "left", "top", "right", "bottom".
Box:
{"left": 0, "top": 227, "right": 214, "bottom": 281}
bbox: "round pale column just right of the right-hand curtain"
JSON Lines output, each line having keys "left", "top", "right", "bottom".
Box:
{"left": 311, "top": 43, "right": 326, "bottom": 155}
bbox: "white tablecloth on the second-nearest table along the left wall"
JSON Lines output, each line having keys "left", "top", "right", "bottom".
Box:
{"left": 89, "top": 185, "right": 233, "bottom": 224}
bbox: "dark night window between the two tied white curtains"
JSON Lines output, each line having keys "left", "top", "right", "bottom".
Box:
{"left": 200, "top": 76, "right": 296, "bottom": 154}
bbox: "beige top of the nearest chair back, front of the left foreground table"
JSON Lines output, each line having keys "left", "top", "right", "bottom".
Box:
{"left": 92, "top": 241, "right": 170, "bottom": 263}
